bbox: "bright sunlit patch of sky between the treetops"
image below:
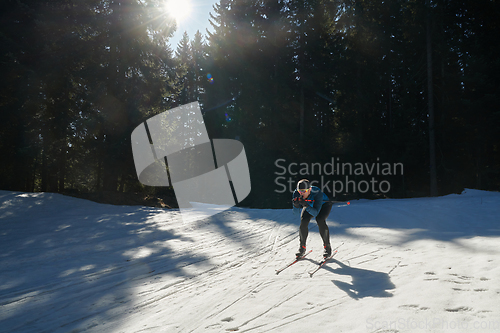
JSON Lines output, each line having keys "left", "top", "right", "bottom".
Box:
{"left": 170, "top": 0, "right": 219, "bottom": 50}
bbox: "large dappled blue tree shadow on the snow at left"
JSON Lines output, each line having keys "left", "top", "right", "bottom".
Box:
{"left": 0, "top": 191, "right": 211, "bottom": 332}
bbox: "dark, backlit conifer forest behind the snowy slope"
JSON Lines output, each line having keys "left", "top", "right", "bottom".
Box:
{"left": 0, "top": 0, "right": 500, "bottom": 208}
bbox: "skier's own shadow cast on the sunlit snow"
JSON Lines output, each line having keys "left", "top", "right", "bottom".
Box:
{"left": 324, "top": 259, "right": 396, "bottom": 300}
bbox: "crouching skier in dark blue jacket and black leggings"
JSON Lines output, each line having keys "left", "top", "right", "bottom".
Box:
{"left": 292, "top": 179, "right": 333, "bottom": 258}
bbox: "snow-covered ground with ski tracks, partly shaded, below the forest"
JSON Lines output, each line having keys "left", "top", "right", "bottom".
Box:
{"left": 0, "top": 190, "right": 500, "bottom": 332}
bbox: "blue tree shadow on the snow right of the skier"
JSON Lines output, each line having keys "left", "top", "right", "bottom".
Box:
{"left": 328, "top": 190, "right": 500, "bottom": 245}
